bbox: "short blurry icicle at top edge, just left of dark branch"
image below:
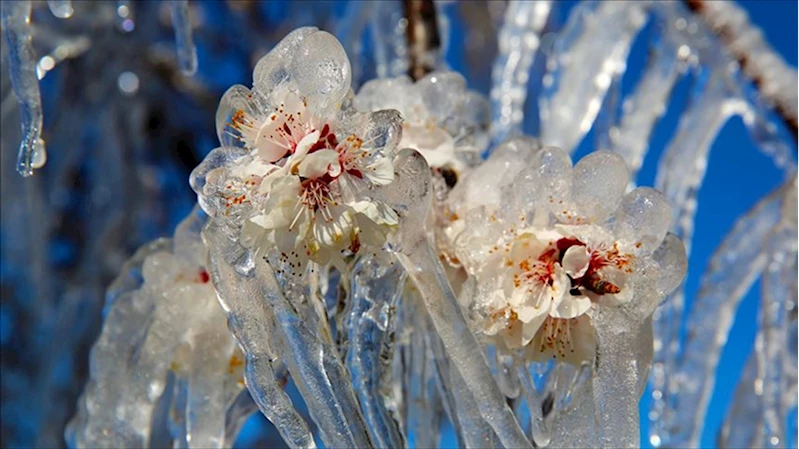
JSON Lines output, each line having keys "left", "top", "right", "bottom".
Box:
{"left": 369, "top": 2, "right": 408, "bottom": 78}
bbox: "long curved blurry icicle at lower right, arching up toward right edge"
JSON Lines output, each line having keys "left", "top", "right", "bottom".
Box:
{"left": 662, "top": 179, "right": 796, "bottom": 447}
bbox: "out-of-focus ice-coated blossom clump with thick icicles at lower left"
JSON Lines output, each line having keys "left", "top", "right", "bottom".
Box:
{"left": 67, "top": 211, "right": 244, "bottom": 448}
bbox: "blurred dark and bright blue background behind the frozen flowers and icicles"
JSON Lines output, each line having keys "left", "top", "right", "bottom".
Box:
{"left": 0, "top": 0, "right": 799, "bottom": 448}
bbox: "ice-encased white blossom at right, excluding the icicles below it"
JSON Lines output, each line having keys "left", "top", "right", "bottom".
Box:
{"left": 445, "top": 140, "right": 685, "bottom": 364}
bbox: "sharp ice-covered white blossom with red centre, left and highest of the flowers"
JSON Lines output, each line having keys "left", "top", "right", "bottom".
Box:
{"left": 192, "top": 28, "right": 402, "bottom": 273}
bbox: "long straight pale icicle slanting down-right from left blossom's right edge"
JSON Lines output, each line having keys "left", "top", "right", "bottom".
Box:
{"left": 389, "top": 150, "right": 530, "bottom": 448}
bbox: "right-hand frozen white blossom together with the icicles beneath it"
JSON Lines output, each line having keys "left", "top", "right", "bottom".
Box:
{"left": 445, "top": 139, "right": 686, "bottom": 447}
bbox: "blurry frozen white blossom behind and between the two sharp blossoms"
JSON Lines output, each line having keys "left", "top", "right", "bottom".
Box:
{"left": 354, "top": 72, "right": 490, "bottom": 179}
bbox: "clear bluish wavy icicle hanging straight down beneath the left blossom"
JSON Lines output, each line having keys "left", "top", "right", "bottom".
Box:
{"left": 347, "top": 254, "right": 406, "bottom": 447}
